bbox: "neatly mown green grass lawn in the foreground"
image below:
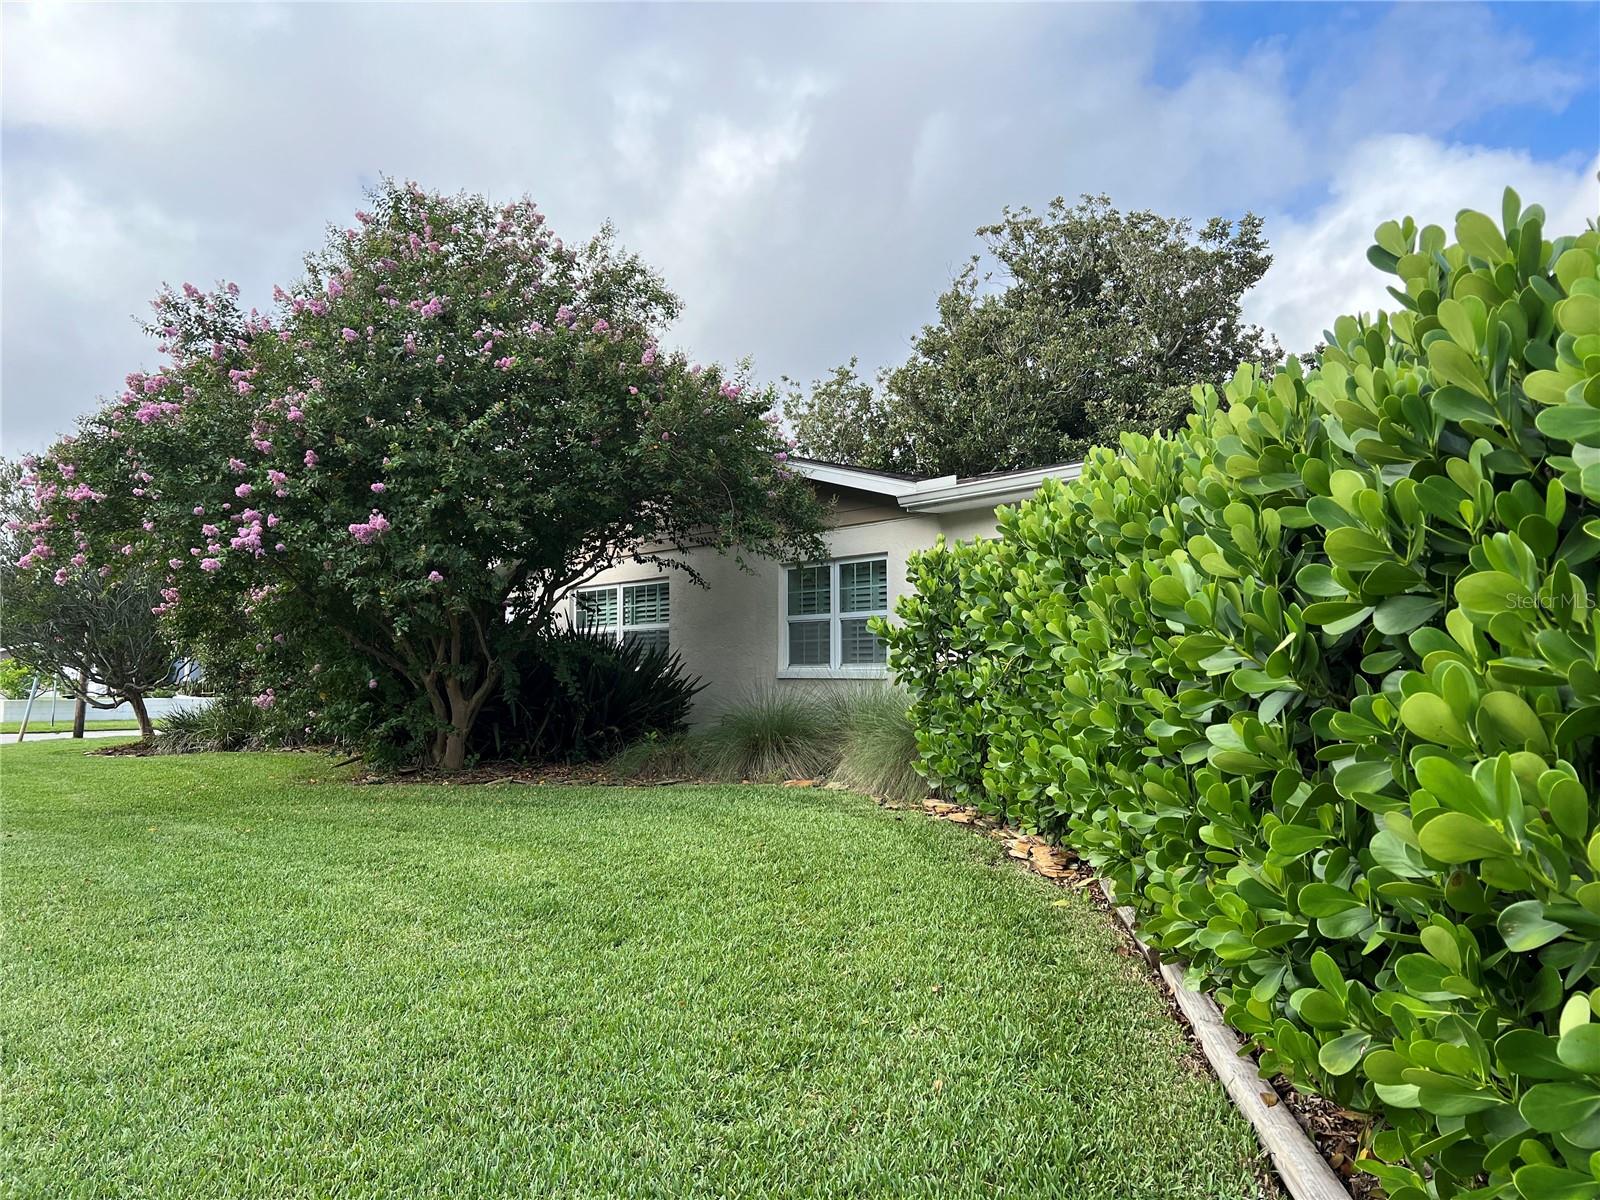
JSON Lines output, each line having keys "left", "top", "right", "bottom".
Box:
{"left": 0, "top": 742, "right": 1259, "bottom": 1200}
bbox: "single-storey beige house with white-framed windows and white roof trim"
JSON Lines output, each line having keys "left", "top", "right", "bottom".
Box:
{"left": 565, "top": 459, "right": 1082, "bottom": 722}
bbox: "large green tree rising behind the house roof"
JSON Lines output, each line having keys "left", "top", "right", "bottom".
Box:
{"left": 789, "top": 197, "right": 1277, "bottom": 475}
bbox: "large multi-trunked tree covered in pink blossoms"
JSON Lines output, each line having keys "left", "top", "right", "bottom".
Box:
{"left": 18, "top": 182, "right": 819, "bottom": 770}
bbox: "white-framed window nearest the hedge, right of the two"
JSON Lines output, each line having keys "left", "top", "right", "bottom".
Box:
{"left": 779, "top": 555, "right": 890, "bottom": 675}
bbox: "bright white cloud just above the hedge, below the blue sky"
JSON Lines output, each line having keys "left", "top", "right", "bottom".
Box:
{"left": 1245, "top": 136, "right": 1600, "bottom": 352}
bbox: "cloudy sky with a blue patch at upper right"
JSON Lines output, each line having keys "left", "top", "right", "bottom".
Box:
{"left": 0, "top": 3, "right": 1600, "bottom": 454}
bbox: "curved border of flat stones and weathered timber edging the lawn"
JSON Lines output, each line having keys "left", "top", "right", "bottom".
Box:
{"left": 915, "top": 803, "right": 1350, "bottom": 1200}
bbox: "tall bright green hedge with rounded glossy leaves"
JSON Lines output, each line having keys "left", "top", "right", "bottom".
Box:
{"left": 888, "top": 192, "right": 1600, "bottom": 1200}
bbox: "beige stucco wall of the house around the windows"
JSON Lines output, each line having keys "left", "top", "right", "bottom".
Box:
{"left": 569, "top": 488, "right": 995, "bottom": 723}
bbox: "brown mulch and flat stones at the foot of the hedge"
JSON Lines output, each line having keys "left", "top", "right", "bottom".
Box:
{"left": 907, "top": 798, "right": 1382, "bottom": 1200}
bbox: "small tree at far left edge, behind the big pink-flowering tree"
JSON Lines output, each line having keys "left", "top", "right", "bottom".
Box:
{"left": 0, "top": 462, "right": 178, "bottom": 738}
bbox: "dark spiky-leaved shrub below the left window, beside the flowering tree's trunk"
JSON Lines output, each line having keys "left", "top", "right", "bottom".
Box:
{"left": 472, "top": 630, "right": 704, "bottom": 760}
